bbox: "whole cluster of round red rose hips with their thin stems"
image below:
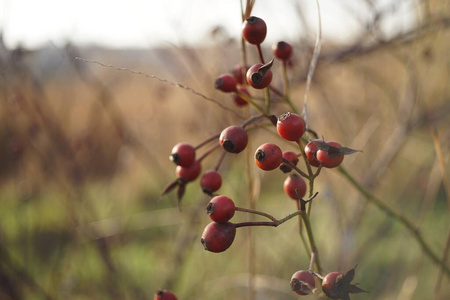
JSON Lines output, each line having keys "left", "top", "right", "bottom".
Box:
{"left": 160, "top": 17, "right": 363, "bottom": 299}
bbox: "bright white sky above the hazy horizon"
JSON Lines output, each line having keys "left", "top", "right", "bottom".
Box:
{"left": 0, "top": 0, "right": 417, "bottom": 48}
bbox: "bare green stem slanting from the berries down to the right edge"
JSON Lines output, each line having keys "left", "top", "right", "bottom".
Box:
{"left": 338, "top": 166, "right": 450, "bottom": 277}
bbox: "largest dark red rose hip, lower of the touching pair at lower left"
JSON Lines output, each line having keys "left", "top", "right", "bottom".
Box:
{"left": 201, "top": 222, "right": 236, "bottom": 253}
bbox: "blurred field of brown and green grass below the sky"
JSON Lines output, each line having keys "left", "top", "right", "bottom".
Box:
{"left": 0, "top": 1, "right": 450, "bottom": 300}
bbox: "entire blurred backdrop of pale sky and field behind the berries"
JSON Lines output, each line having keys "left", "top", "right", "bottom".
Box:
{"left": 0, "top": 0, "right": 450, "bottom": 300}
